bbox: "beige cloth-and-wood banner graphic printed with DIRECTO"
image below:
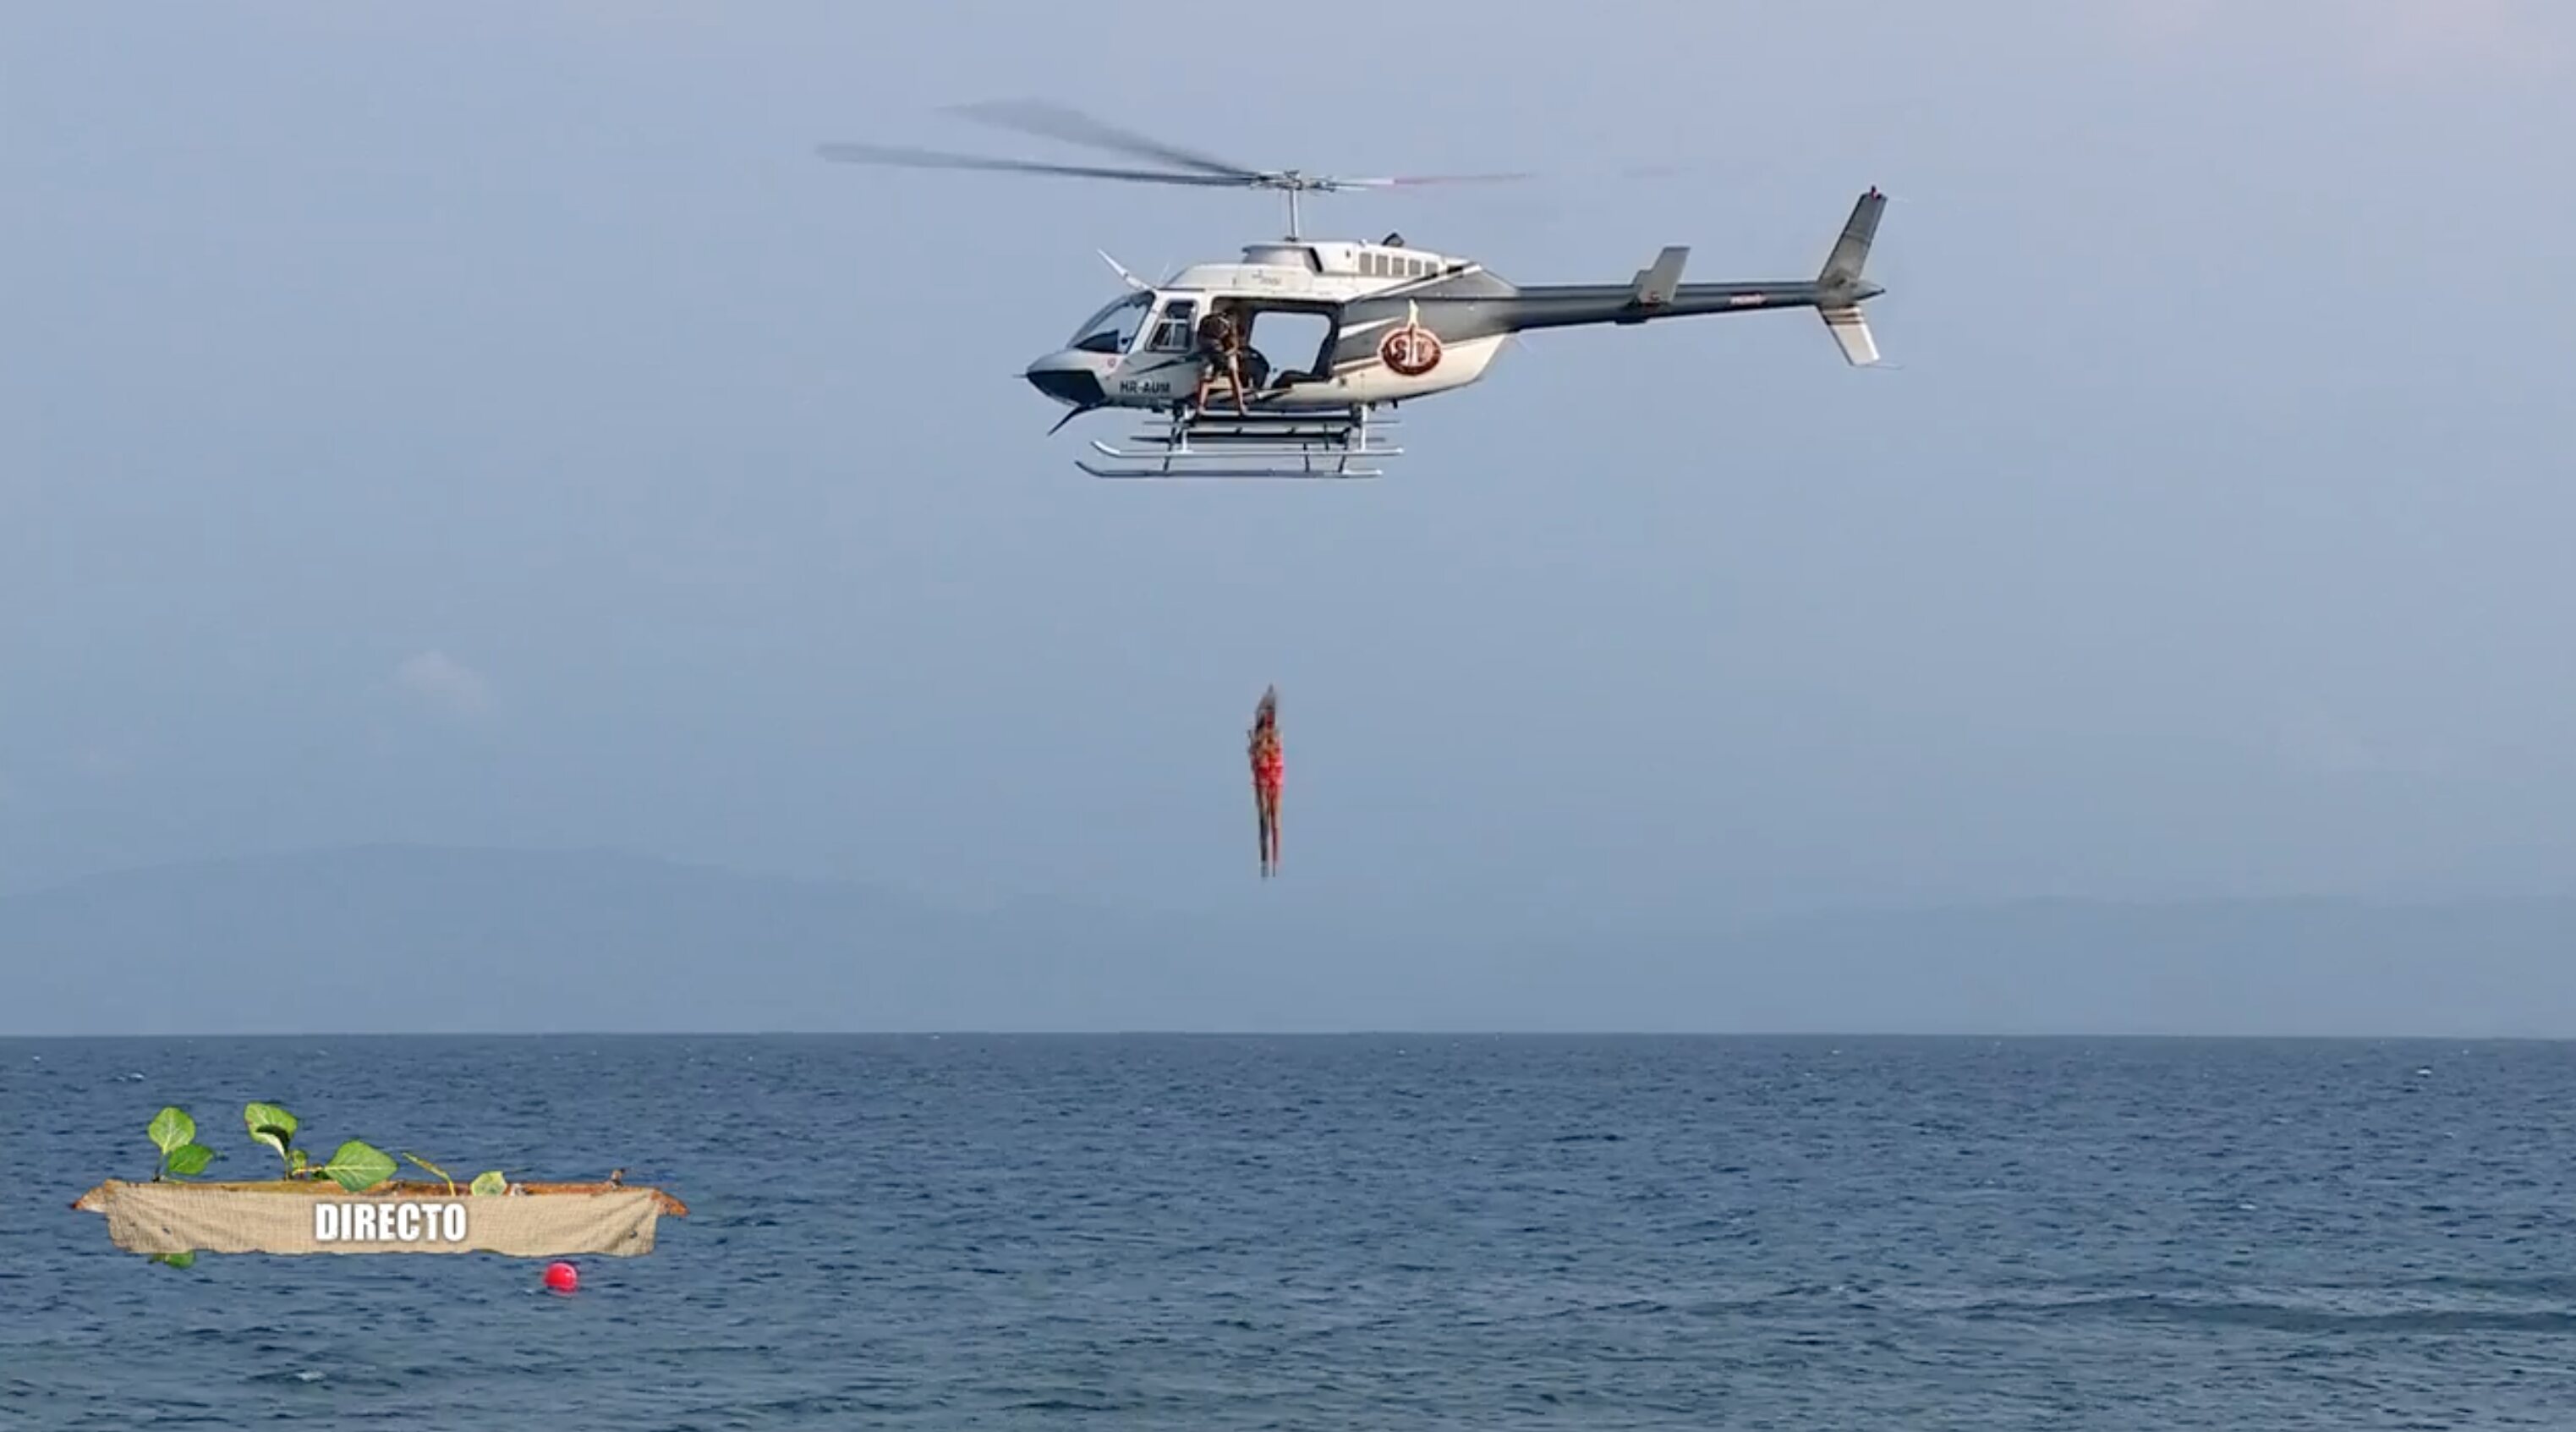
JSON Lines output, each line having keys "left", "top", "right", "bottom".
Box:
{"left": 72, "top": 1180, "right": 688, "bottom": 1257}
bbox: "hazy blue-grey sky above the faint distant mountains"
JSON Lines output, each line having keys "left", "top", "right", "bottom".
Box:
{"left": 0, "top": 0, "right": 2576, "bottom": 927}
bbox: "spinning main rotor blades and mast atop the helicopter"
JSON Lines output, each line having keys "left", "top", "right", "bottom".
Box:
{"left": 817, "top": 101, "right": 1532, "bottom": 239}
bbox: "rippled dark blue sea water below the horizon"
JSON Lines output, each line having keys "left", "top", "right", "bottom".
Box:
{"left": 0, "top": 1035, "right": 2576, "bottom": 1432}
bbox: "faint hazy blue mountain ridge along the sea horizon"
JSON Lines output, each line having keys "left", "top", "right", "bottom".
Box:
{"left": 0, "top": 845, "right": 2576, "bottom": 1038}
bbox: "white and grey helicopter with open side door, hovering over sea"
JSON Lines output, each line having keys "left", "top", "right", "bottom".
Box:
{"left": 817, "top": 101, "right": 1886, "bottom": 479}
